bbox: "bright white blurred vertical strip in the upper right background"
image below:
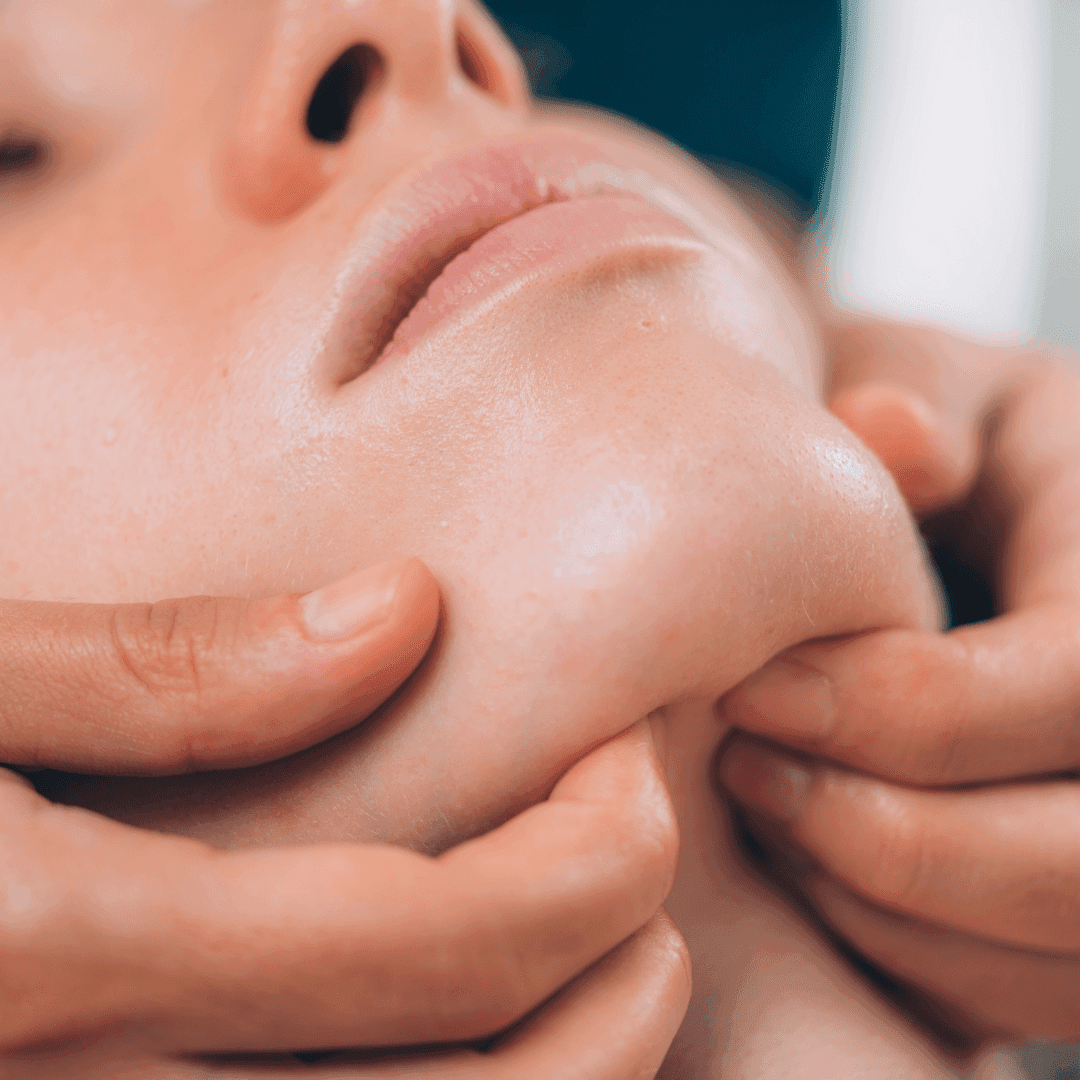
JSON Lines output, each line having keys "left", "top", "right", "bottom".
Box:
{"left": 824, "top": 0, "right": 1049, "bottom": 338}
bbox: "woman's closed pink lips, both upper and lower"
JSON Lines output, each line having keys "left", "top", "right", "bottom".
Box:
{"left": 335, "top": 133, "right": 705, "bottom": 382}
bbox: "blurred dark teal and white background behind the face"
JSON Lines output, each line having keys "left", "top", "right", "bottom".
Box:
{"left": 488, "top": 0, "right": 1080, "bottom": 1080}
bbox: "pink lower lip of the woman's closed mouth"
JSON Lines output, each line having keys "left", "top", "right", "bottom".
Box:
{"left": 381, "top": 197, "right": 706, "bottom": 360}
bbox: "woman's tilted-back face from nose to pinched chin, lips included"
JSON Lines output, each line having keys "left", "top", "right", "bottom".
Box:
{"left": 0, "top": 0, "right": 934, "bottom": 757}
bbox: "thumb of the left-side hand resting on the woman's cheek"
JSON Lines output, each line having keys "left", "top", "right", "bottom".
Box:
{"left": 0, "top": 558, "right": 438, "bottom": 775}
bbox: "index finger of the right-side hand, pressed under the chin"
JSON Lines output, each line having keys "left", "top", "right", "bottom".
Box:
{"left": 724, "top": 602, "right": 1080, "bottom": 785}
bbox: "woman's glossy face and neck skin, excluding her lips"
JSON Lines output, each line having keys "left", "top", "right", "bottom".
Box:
{"left": 0, "top": 0, "right": 980, "bottom": 1077}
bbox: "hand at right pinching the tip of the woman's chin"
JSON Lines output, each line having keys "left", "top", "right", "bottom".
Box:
{"left": 719, "top": 323, "right": 1080, "bottom": 1040}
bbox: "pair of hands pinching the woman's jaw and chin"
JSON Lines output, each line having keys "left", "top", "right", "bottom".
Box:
{"left": 8, "top": 323, "right": 1080, "bottom": 1067}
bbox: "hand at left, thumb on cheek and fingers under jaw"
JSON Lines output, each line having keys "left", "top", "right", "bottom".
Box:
{"left": 0, "top": 559, "right": 689, "bottom": 1080}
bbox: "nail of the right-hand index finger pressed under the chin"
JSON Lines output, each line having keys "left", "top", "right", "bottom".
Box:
{"left": 735, "top": 660, "right": 836, "bottom": 737}
